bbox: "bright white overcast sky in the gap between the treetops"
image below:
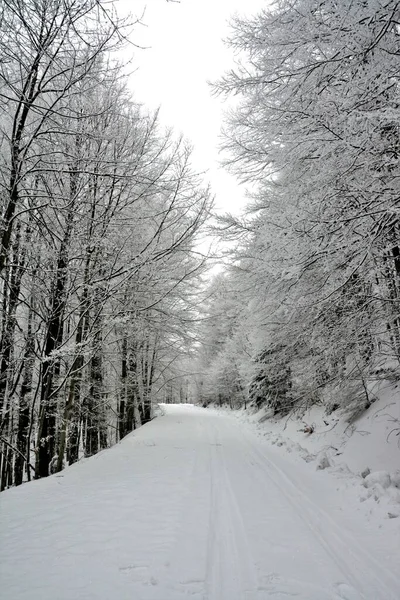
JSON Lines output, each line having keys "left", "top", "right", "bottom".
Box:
{"left": 122, "top": 0, "right": 268, "bottom": 212}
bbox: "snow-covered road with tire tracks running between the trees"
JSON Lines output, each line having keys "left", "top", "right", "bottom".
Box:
{"left": 0, "top": 405, "right": 400, "bottom": 600}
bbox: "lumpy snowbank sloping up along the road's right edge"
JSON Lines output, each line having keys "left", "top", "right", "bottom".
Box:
{"left": 227, "top": 382, "right": 400, "bottom": 524}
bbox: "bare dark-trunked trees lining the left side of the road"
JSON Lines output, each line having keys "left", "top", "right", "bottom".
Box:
{"left": 0, "top": 0, "right": 210, "bottom": 490}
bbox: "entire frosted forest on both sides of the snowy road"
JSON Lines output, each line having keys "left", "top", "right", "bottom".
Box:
{"left": 0, "top": 0, "right": 400, "bottom": 490}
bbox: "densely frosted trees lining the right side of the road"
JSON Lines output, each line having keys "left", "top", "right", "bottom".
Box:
{"left": 198, "top": 0, "right": 400, "bottom": 418}
